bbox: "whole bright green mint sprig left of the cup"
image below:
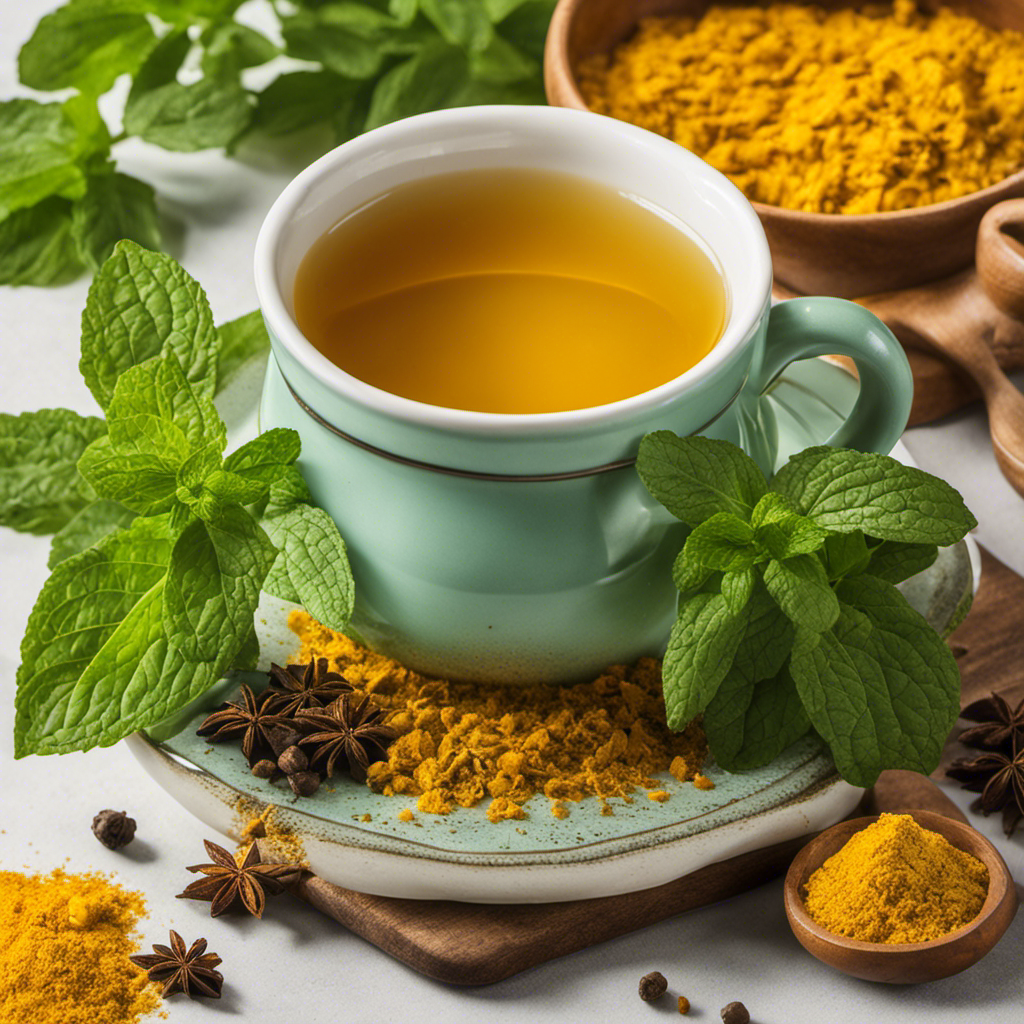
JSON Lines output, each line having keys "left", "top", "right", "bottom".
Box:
{"left": 11, "top": 242, "right": 352, "bottom": 757}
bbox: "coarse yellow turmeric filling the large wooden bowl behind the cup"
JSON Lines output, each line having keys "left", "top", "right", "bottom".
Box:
{"left": 577, "top": 0, "right": 1024, "bottom": 214}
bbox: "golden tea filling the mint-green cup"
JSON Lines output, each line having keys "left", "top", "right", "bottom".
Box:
{"left": 294, "top": 169, "right": 726, "bottom": 413}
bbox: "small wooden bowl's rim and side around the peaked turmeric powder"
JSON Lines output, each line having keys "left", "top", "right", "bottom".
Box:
{"left": 783, "top": 810, "right": 1017, "bottom": 956}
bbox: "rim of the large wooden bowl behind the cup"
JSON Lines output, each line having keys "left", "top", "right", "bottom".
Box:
{"left": 544, "top": 0, "right": 1024, "bottom": 227}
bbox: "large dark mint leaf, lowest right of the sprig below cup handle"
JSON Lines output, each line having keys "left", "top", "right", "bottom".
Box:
{"left": 791, "top": 575, "right": 959, "bottom": 786}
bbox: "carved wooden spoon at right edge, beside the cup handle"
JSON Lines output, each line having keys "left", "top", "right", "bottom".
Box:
{"left": 859, "top": 199, "right": 1024, "bottom": 496}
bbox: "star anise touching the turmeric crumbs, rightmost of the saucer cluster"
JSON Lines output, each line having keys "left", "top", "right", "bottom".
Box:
{"left": 295, "top": 693, "right": 397, "bottom": 782}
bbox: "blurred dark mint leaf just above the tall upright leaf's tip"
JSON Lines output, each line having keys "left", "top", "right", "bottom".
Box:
{"left": 72, "top": 165, "right": 160, "bottom": 270}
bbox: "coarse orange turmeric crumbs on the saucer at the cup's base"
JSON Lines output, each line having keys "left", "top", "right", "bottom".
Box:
{"left": 289, "top": 610, "right": 708, "bottom": 821}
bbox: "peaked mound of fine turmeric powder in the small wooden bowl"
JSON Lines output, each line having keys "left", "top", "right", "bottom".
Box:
{"left": 805, "top": 814, "right": 988, "bottom": 943}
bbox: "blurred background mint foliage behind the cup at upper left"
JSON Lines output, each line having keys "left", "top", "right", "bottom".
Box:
{"left": 0, "top": 0, "right": 554, "bottom": 285}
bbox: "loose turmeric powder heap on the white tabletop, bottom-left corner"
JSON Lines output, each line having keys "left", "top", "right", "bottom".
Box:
{"left": 0, "top": 868, "right": 160, "bottom": 1024}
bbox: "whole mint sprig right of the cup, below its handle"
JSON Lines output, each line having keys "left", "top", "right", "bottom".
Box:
{"left": 637, "top": 431, "right": 976, "bottom": 785}
